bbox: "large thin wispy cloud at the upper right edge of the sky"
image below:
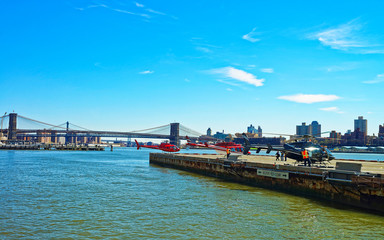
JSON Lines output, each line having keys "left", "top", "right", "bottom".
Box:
{"left": 307, "top": 19, "right": 384, "bottom": 54}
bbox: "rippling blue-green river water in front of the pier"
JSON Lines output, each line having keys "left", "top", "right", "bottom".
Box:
{"left": 0, "top": 148, "right": 384, "bottom": 239}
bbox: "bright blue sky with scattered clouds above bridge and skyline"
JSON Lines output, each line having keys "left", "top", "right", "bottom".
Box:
{"left": 0, "top": 0, "right": 384, "bottom": 135}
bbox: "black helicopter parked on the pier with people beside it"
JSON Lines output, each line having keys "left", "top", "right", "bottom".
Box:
{"left": 243, "top": 133, "right": 335, "bottom": 165}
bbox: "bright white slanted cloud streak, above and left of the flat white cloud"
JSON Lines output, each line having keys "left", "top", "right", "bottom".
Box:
{"left": 209, "top": 67, "right": 265, "bottom": 87}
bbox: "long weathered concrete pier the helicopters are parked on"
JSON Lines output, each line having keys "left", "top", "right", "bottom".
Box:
{"left": 150, "top": 153, "right": 384, "bottom": 214}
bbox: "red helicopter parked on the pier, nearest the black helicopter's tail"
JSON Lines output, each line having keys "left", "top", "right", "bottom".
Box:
{"left": 186, "top": 136, "right": 251, "bottom": 155}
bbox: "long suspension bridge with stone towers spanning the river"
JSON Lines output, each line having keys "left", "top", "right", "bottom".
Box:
{"left": 0, "top": 113, "right": 216, "bottom": 146}
